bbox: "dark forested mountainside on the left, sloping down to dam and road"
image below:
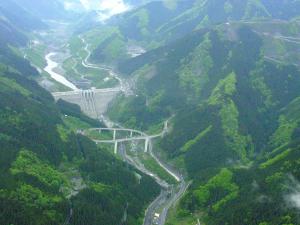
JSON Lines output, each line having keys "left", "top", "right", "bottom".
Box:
{"left": 0, "top": 1, "right": 159, "bottom": 225}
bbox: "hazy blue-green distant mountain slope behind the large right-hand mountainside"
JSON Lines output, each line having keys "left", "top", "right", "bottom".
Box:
{"left": 84, "top": 0, "right": 300, "bottom": 66}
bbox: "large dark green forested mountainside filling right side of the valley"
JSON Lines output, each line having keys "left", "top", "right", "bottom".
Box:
{"left": 101, "top": 1, "right": 300, "bottom": 225}
